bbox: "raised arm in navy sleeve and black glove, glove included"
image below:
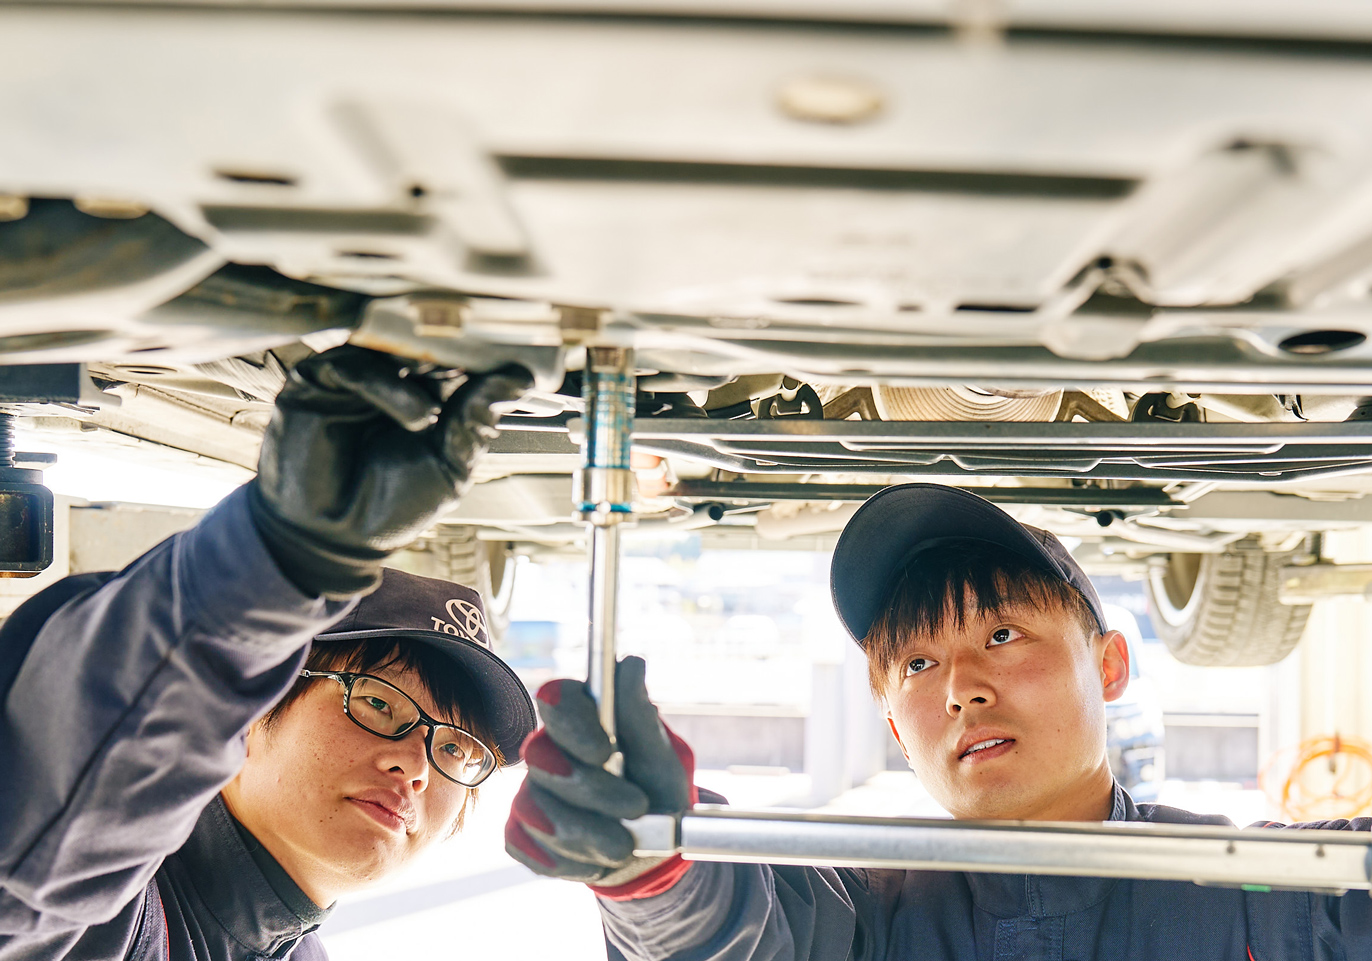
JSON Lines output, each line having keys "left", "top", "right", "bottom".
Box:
{"left": 0, "top": 347, "right": 530, "bottom": 945}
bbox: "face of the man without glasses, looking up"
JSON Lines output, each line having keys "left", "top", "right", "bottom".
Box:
{"left": 885, "top": 604, "right": 1129, "bottom": 821}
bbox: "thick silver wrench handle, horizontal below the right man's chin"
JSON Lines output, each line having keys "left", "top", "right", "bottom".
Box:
{"left": 626, "top": 807, "right": 1372, "bottom": 891}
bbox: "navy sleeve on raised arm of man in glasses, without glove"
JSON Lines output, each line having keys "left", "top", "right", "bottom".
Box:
{"left": 0, "top": 489, "right": 350, "bottom": 939}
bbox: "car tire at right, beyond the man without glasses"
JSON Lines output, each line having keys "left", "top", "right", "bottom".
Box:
{"left": 1147, "top": 538, "right": 1310, "bottom": 667}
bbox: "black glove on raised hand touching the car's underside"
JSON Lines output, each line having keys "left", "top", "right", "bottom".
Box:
{"left": 248, "top": 346, "right": 534, "bottom": 599}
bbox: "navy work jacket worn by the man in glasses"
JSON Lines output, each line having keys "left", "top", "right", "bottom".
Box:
{"left": 0, "top": 490, "right": 350, "bottom": 961}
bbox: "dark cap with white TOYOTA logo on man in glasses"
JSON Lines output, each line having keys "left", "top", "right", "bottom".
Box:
{"left": 314, "top": 568, "right": 538, "bottom": 765}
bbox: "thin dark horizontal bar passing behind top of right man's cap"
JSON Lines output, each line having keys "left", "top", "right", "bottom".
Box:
{"left": 665, "top": 481, "right": 1181, "bottom": 509}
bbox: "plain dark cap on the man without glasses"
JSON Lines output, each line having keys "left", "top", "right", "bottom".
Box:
{"left": 829, "top": 483, "right": 1109, "bottom": 641}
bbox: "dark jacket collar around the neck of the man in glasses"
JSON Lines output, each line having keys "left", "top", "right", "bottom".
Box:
{"left": 159, "top": 796, "right": 329, "bottom": 958}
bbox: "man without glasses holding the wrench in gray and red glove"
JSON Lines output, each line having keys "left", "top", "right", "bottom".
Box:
{"left": 506, "top": 485, "right": 1372, "bottom": 961}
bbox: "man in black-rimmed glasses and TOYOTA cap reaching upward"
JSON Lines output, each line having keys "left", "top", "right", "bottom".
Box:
{"left": 0, "top": 347, "right": 534, "bottom": 961}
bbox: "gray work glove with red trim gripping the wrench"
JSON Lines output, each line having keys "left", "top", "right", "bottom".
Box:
{"left": 505, "top": 658, "right": 697, "bottom": 896}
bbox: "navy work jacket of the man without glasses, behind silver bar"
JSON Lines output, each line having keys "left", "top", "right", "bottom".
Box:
{"left": 600, "top": 785, "right": 1372, "bottom": 961}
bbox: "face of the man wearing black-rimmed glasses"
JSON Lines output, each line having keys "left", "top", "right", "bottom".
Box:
{"left": 224, "top": 669, "right": 468, "bottom": 905}
